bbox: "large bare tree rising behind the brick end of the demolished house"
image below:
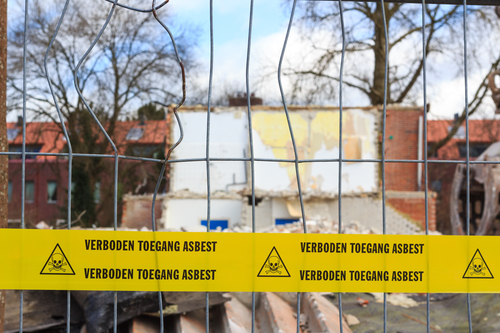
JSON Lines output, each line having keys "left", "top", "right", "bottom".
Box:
{"left": 285, "top": 1, "right": 491, "bottom": 105}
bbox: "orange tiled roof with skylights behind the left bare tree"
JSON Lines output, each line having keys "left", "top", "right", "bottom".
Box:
{"left": 7, "top": 120, "right": 166, "bottom": 159}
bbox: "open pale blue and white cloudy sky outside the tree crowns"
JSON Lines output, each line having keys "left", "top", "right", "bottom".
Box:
{"left": 168, "top": 0, "right": 500, "bottom": 119}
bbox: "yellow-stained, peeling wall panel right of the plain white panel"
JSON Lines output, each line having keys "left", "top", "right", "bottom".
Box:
{"left": 252, "top": 108, "right": 378, "bottom": 194}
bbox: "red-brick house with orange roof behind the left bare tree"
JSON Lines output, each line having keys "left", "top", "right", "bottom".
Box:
{"left": 7, "top": 119, "right": 167, "bottom": 226}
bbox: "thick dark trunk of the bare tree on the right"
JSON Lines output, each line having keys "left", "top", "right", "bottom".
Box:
{"left": 369, "top": 2, "right": 391, "bottom": 105}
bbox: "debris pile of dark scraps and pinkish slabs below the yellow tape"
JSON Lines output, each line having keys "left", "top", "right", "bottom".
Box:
{"left": 4, "top": 290, "right": 359, "bottom": 333}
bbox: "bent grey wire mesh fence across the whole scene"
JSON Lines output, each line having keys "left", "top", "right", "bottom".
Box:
{"left": 0, "top": 0, "right": 488, "bottom": 333}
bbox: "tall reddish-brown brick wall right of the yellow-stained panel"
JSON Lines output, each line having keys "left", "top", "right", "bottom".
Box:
{"left": 385, "top": 108, "right": 423, "bottom": 191}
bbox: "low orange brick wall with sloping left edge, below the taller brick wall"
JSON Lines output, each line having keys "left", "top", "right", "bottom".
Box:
{"left": 387, "top": 192, "right": 436, "bottom": 231}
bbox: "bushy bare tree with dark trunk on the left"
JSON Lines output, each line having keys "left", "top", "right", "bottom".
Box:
{"left": 9, "top": 0, "right": 195, "bottom": 222}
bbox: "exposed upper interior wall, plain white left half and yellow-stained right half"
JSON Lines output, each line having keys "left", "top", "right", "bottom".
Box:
{"left": 171, "top": 107, "right": 378, "bottom": 194}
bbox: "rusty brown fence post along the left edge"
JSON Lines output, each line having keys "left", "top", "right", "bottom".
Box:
{"left": 0, "top": 0, "right": 9, "bottom": 333}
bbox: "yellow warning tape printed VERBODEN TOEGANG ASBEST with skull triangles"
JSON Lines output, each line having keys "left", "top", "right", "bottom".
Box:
{"left": 0, "top": 229, "right": 500, "bottom": 293}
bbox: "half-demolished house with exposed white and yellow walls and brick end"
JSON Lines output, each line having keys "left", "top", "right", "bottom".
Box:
{"left": 122, "top": 105, "right": 435, "bottom": 233}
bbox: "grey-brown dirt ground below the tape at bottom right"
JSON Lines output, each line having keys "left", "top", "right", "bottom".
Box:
{"left": 330, "top": 293, "right": 500, "bottom": 333}
